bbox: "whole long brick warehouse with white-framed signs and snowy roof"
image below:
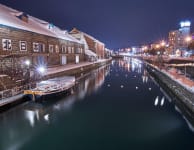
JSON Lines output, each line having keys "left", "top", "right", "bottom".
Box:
{"left": 0, "top": 4, "right": 85, "bottom": 78}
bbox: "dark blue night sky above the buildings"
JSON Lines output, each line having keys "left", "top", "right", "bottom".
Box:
{"left": 0, "top": 0, "right": 194, "bottom": 49}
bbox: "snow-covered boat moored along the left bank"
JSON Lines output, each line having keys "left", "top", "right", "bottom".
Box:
{"left": 24, "top": 76, "right": 75, "bottom": 101}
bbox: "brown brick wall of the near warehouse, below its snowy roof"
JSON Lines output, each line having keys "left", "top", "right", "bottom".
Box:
{"left": 0, "top": 25, "right": 84, "bottom": 72}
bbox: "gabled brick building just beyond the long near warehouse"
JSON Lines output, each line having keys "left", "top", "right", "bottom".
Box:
{"left": 70, "top": 28, "right": 105, "bottom": 59}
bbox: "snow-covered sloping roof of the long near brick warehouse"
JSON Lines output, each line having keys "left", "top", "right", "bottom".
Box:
{"left": 0, "top": 4, "right": 83, "bottom": 44}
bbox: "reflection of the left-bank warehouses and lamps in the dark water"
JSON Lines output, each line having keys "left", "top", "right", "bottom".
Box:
{"left": 22, "top": 66, "right": 110, "bottom": 127}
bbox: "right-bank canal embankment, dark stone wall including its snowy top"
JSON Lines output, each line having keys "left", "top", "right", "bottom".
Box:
{"left": 146, "top": 63, "right": 194, "bottom": 119}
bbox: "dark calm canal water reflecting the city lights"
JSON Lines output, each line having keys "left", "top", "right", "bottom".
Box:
{"left": 0, "top": 58, "right": 194, "bottom": 150}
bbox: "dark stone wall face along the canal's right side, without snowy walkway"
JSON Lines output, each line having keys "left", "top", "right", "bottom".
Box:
{"left": 146, "top": 63, "right": 194, "bottom": 116}
